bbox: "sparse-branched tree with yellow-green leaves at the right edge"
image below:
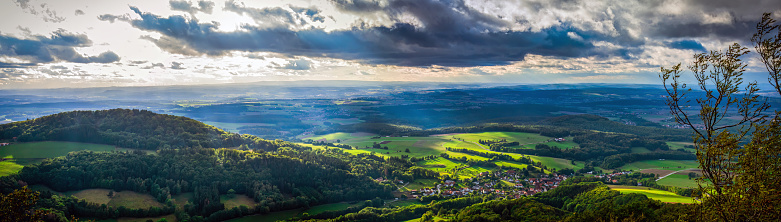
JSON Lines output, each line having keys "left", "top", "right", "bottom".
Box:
{"left": 659, "top": 13, "right": 781, "bottom": 221}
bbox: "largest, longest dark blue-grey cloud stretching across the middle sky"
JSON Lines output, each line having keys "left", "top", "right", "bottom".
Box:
{"left": 108, "top": 1, "right": 596, "bottom": 66}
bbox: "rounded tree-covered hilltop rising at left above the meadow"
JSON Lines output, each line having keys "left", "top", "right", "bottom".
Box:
{"left": 0, "top": 109, "right": 285, "bottom": 150}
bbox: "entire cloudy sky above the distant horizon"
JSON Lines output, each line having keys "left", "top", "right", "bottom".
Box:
{"left": 0, "top": 0, "right": 781, "bottom": 89}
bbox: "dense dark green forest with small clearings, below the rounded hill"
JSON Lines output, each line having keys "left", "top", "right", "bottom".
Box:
{"left": 0, "top": 143, "right": 444, "bottom": 221}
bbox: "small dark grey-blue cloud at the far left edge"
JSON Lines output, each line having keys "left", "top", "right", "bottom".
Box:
{"left": 0, "top": 30, "right": 120, "bottom": 67}
